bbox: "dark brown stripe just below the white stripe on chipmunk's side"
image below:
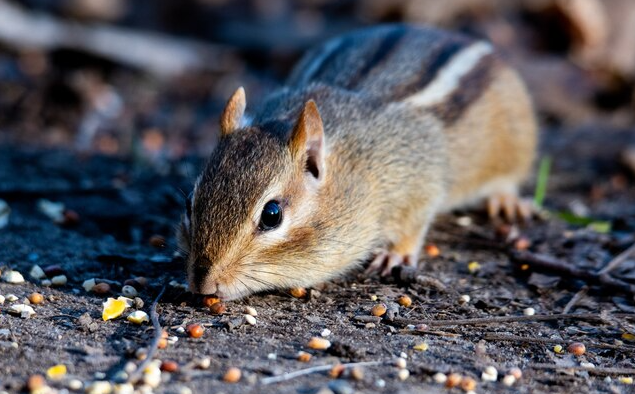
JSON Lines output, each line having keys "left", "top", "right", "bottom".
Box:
{"left": 432, "top": 54, "right": 497, "bottom": 125}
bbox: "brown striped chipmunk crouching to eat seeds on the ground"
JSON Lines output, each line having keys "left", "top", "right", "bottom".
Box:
{"left": 179, "top": 25, "right": 537, "bottom": 300}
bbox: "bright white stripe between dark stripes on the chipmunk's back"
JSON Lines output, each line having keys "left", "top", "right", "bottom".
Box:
{"left": 403, "top": 42, "right": 493, "bottom": 107}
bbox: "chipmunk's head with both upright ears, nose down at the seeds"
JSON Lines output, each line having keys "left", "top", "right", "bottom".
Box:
{"left": 179, "top": 88, "right": 326, "bottom": 299}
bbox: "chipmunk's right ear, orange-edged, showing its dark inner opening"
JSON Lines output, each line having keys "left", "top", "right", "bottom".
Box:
{"left": 289, "top": 100, "right": 325, "bottom": 180}
